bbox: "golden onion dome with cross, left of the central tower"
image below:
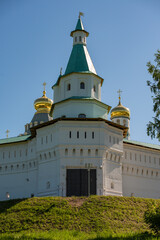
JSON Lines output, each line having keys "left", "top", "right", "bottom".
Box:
{"left": 34, "top": 83, "right": 53, "bottom": 113}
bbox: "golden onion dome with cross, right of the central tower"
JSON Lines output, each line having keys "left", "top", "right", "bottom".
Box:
{"left": 111, "top": 97, "right": 130, "bottom": 120}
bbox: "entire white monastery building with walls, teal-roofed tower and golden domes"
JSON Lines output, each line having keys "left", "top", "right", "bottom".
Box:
{"left": 0, "top": 16, "right": 160, "bottom": 201}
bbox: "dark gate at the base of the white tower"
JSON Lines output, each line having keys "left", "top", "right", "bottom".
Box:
{"left": 66, "top": 169, "right": 96, "bottom": 196}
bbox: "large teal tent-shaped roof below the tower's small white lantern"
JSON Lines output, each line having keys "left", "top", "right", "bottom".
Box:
{"left": 65, "top": 44, "right": 97, "bottom": 75}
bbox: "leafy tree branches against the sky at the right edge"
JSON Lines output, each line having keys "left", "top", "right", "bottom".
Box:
{"left": 147, "top": 50, "right": 160, "bottom": 141}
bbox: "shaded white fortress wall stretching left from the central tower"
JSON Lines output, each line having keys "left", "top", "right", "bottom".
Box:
{"left": 0, "top": 139, "right": 38, "bottom": 200}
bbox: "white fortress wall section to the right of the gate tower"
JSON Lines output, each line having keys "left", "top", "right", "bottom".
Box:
{"left": 122, "top": 144, "right": 160, "bottom": 198}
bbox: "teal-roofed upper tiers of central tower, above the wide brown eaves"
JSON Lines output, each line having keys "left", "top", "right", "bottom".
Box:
{"left": 51, "top": 15, "right": 110, "bottom": 119}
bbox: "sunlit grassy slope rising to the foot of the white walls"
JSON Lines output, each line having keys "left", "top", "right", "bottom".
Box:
{"left": 0, "top": 196, "right": 160, "bottom": 239}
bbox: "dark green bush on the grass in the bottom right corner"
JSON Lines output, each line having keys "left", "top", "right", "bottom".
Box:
{"left": 144, "top": 205, "right": 160, "bottom": 233}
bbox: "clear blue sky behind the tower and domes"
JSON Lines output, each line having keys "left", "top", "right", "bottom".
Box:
{"left": 0, "top": 0, "right": 160, "bottom": 143}
